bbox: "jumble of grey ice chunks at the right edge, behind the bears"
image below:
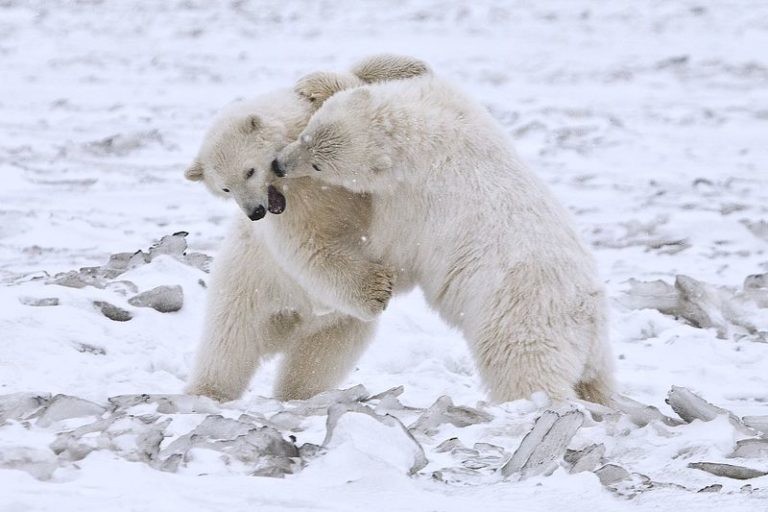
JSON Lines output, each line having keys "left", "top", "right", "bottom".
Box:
{"left": 619, "top": 274, "right": 768, "bottom": 340}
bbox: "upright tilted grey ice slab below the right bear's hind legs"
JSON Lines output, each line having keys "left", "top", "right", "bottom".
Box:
{"left": 501, "top": 410, "right": 584, "bottom": 478}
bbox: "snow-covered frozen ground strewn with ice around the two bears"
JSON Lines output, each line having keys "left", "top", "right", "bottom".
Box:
{"left": 0, "top": 0, "right": 768, "bottom": 512}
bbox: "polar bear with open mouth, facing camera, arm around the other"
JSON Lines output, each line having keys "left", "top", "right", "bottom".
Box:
{"left": 185, "top": 55, "right": 429, "bottom": 400}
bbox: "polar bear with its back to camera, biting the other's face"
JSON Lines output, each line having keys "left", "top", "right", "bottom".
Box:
{"left": 275, "top": 75, "right": 613, "bottom": 403}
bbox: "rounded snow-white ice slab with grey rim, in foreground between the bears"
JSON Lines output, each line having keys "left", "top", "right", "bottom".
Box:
{"left": 322, "top": 403, "right": 428, "bottom": 475}
